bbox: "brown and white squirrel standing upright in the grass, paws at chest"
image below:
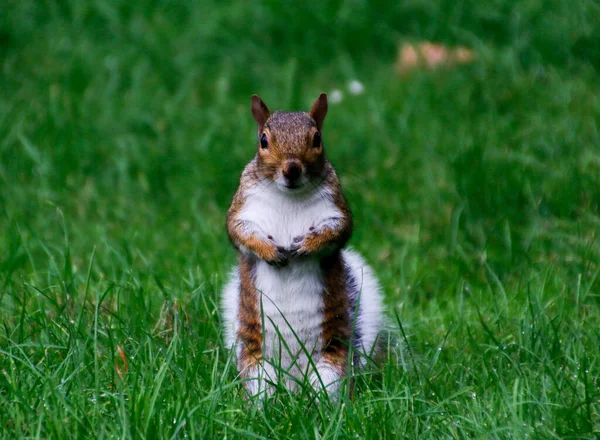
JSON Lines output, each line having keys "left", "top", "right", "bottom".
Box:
{"left": 223, "top": 93, "right": 382, "bottom": 396}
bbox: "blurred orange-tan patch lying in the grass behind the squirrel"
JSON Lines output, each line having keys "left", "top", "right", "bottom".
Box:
{"left": 396, "top": 41, "right": 475, "bottom": 74}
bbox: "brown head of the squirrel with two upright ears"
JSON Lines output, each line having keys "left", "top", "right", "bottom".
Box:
{"left": 252, "top": 93, "right": 327, "bottom": 191}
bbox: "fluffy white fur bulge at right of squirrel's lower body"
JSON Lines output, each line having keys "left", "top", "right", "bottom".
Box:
{"left": 342, "top": 249, "right": 383, "bottom": 367}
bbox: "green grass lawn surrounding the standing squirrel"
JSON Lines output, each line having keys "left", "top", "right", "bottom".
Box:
{"left": 0, "top": 0, "right": 600, "bottom": 439}
